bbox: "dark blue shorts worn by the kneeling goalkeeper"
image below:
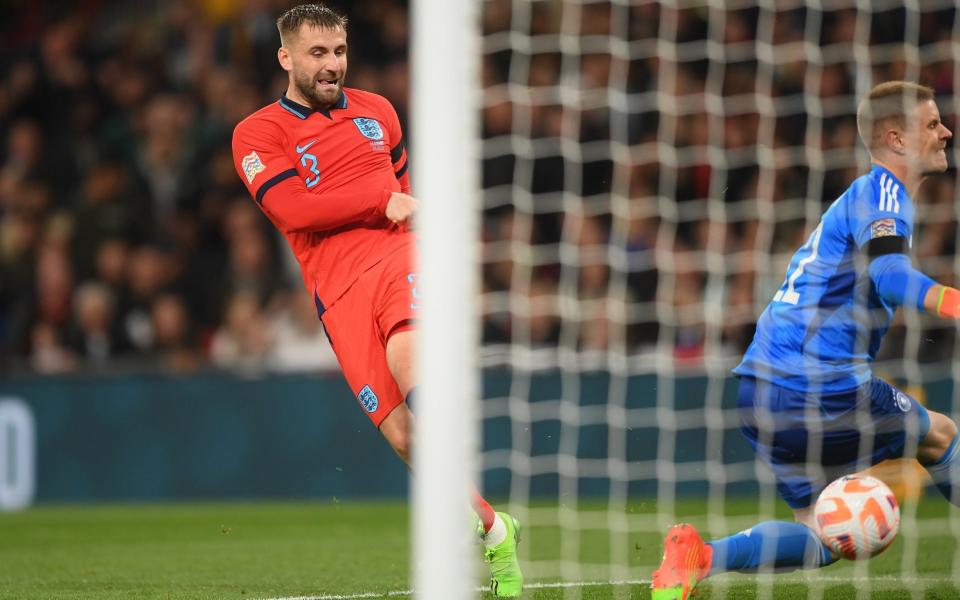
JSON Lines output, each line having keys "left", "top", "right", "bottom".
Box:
{"left": 737, "top": 377, "right": 930, "bottom": 509}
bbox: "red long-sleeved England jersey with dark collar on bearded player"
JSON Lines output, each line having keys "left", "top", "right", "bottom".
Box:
{"left": 233, "top": 88, "right": 414, "bottom": 306}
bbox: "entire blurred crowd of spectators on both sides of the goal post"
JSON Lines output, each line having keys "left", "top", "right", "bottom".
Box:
{"left": 0, "top": 0, "right": 958, "bottom": 373}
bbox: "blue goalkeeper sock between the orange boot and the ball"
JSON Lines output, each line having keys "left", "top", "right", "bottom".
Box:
{"left": 708, "top": 521, "right": 837, "bottom": 575}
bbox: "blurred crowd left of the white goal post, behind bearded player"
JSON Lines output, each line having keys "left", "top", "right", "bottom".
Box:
{"left": 0, "top": 1, "right": 407, "bottom": 373}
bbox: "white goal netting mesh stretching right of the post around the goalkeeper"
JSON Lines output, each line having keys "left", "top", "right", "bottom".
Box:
{"left": 480, "top": 0, "right": 960, "bottom": 595}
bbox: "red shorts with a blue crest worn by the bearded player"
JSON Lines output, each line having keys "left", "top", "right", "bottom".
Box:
{"left": 320, "top": 252, "right": 417, "bottom": 427}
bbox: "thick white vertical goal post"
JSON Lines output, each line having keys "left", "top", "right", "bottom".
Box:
{"left": 410, "top": 0, "right": 480, "bottom": 600}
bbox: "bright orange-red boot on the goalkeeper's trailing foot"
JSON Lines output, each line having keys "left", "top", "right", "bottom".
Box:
{"left": 650, "top": 523, "right": 713, "bottom": 600}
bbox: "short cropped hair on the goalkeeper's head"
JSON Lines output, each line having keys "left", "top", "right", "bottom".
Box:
{"left": 857, "top": 81, "right": 934, "bottom": 150}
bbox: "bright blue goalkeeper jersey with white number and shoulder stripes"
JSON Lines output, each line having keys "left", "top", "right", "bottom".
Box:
{"left": 733, "top": 165, "right": 913, "bottom": 394}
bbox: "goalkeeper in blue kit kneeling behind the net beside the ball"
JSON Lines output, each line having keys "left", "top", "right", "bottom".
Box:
{"left": 652, "top": 81, "right": 960, "bottom": 600}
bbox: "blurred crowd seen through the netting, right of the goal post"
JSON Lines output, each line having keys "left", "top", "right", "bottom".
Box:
{"left": 483, "top": 0, "right": 960, "bottom": 366}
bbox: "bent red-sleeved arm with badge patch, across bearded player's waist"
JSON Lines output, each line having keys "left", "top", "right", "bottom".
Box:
{"left": 233, "top": 119, "right": 397, "bottom": 231}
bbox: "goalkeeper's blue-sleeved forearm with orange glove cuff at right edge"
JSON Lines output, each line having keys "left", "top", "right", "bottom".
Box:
{"left": 870, "top": 253, "right": 960, "bottom": 319}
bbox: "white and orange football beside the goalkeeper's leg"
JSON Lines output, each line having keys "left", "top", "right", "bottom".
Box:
{"left": 814, "top": 475, "right": 900, "bottom": 560}
